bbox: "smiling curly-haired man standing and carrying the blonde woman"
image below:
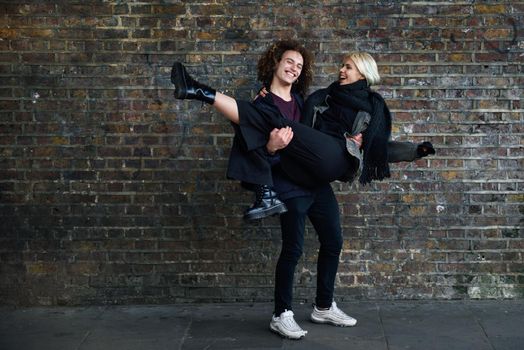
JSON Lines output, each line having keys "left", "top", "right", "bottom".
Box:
{"left": 249, "top": 42, "right": 357, "bottom": 339}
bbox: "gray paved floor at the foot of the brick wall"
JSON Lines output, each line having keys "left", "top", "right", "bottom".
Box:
{"left": 0, "top": 300, "right": 524, "bottom": 350}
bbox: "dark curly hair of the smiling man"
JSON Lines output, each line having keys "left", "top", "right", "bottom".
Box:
{"left": 257, "top": 39, "right": 313, "bottom": 96}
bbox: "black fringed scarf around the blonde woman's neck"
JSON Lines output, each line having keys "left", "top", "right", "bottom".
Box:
{"left": 328, "top": 80, "right": 391, "bottom": 184}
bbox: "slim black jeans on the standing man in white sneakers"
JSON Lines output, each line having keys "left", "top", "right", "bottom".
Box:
{"left": 274, "top": 184, "right": 343, "bottom": 316}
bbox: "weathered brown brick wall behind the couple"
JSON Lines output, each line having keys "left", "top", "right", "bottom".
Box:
{"left": 0, "top": 0, "right": 524, "bottom": 305}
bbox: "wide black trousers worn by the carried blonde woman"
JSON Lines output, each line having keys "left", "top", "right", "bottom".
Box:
{"left": 227, "top": 101, "right": 358, "bottom": 187}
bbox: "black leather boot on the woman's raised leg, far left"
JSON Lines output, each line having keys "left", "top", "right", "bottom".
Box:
{"left": 171, "top": 62, "right": 216, "bottom": 105}
